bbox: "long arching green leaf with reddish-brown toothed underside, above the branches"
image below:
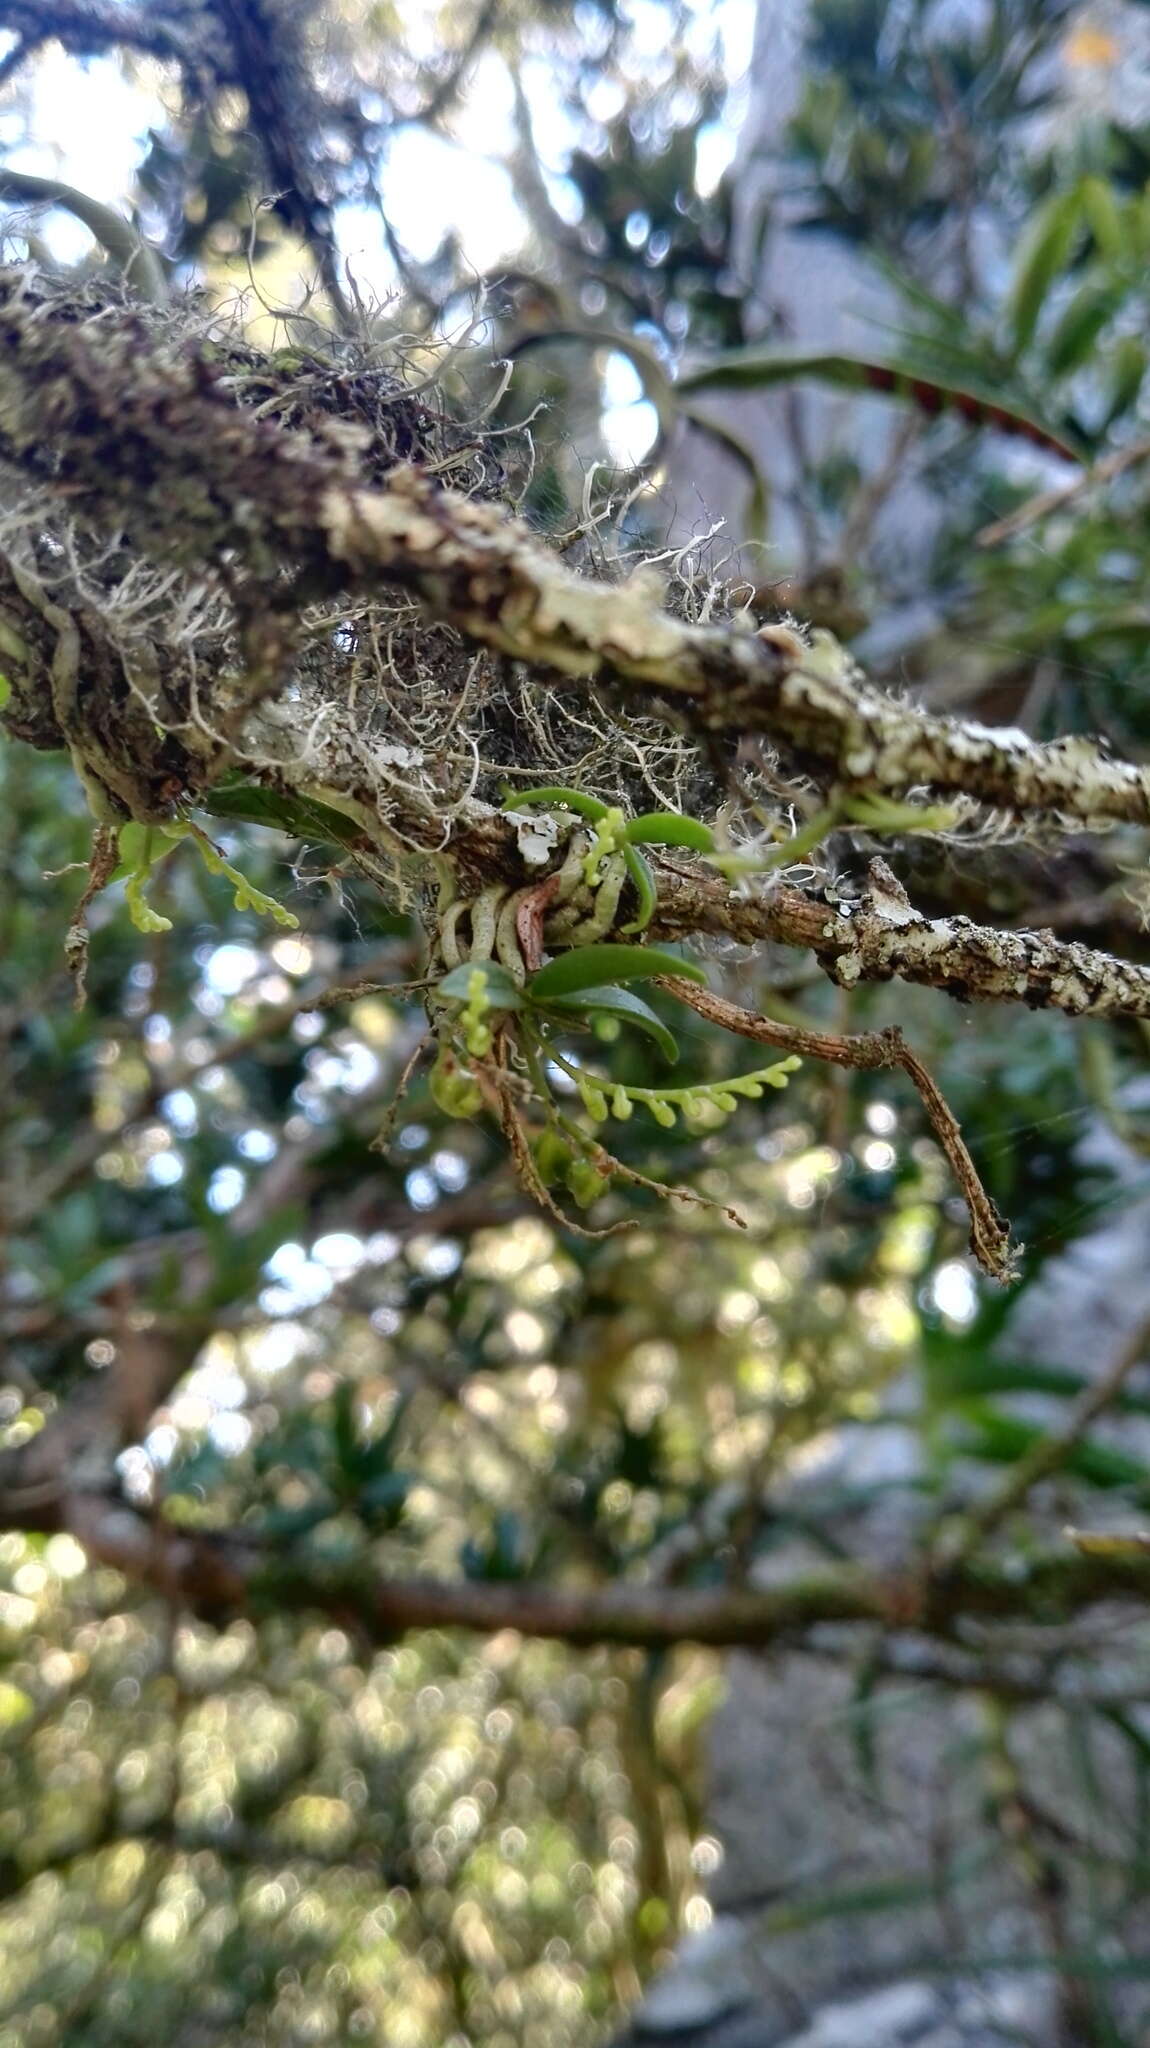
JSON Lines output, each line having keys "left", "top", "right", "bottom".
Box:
{"left": 679, "top": 346, "right": 1085, "bottom": 463}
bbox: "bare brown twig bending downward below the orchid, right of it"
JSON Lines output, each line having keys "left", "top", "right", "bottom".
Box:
{"left": 655, "top": 975, "right": 1017, "bottom": 1280}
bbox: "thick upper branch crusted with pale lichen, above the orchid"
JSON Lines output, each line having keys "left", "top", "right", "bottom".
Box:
{"left": 0, "top": 270, "right": 1150, "bottom": 823}
